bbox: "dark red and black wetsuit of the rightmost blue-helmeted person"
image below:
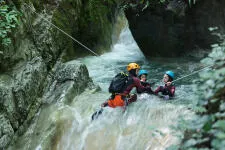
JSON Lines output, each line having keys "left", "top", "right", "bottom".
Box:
{"left": 154, "top": 85, "right": 175, "bottom": 97}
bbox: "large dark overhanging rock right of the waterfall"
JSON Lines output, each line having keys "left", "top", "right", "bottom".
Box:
{"left": 125, "top": 0, "right": 225, "bottom": 56}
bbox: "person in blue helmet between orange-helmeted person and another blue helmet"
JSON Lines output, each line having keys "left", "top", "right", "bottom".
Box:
{"left": 137, "top": 69, "right": 154, "bottom": 94}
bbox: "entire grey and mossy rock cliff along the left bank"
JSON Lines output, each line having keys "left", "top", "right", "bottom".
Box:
{"left": 0, "top": 0, "right": 117, "bottom": 149}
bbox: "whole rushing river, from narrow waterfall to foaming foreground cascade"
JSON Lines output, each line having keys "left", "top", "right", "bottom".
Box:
{"left": 9, "top": 28, "right": 200, "bottom": 150}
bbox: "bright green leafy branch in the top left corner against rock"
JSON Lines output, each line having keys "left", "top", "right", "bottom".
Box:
{"left": 0, "top": 1, "right": 19, "bottom": 46}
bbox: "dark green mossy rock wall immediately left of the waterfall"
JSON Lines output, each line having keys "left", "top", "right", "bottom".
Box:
{"left": 53, "top": 0, "right": 117, "bottom": 60}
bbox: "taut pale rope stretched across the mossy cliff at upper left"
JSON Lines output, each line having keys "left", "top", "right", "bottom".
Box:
{"left": 24, "top": 4, "right": 99, "bottom": 56}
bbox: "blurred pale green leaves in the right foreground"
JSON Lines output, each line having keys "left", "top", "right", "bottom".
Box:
{"left": 174, "top": 42, "right": 225, "bottom": 150}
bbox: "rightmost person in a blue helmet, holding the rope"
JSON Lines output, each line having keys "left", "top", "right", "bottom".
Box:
{"left": 154, "top": 71, "right": 175, "bottom": 100}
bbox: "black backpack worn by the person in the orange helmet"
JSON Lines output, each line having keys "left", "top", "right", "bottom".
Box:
{"left": 109, "top": 72, "right": 128, "bottom": 93}
